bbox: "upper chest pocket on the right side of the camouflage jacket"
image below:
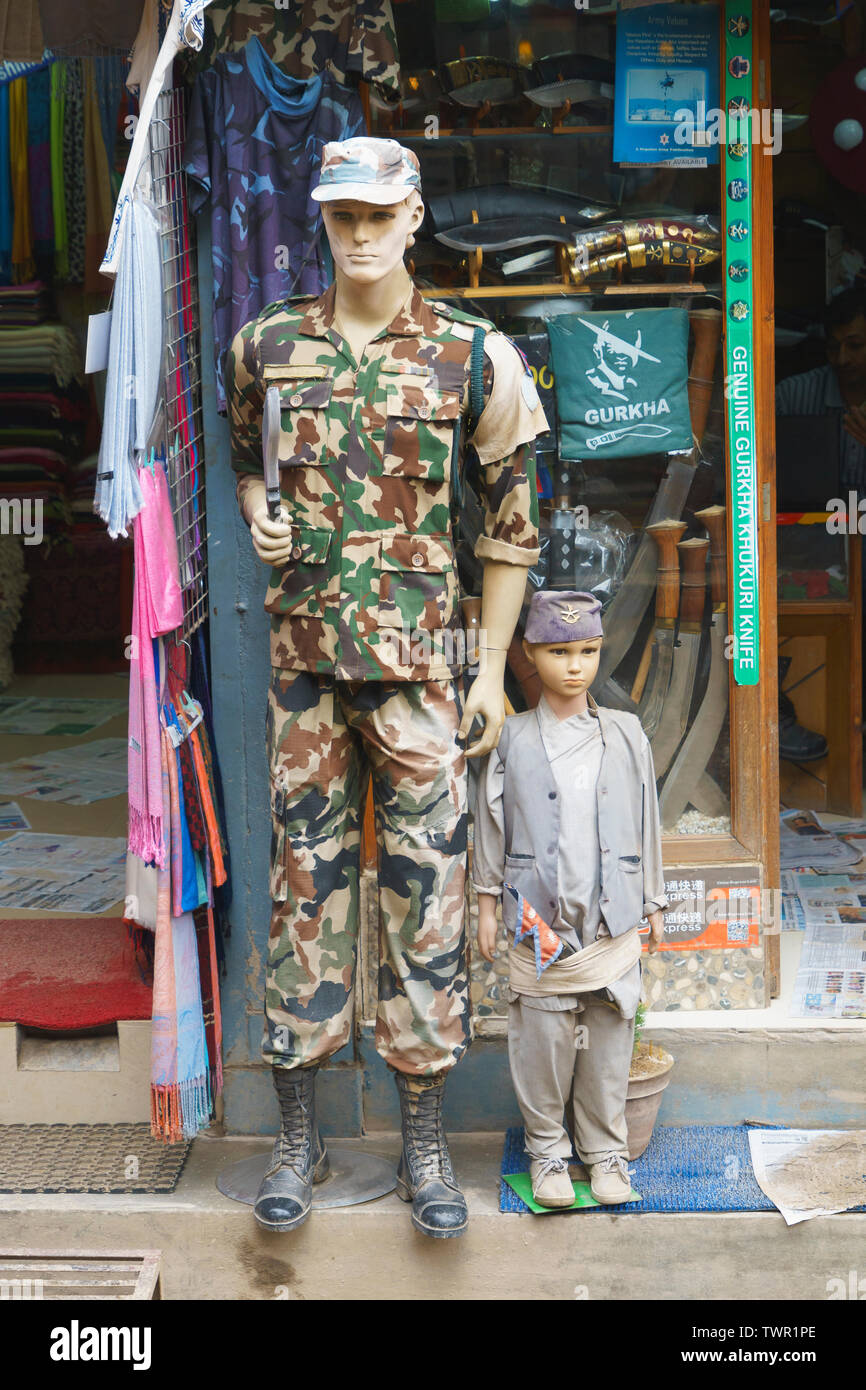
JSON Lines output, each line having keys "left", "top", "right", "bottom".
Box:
{"left": 382, "top": 377, "right": 460, "bottom": 482}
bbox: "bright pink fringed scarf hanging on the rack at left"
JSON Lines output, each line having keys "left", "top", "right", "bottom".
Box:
{"left": 128, "top": 464, "right": 183, "bottom": 869}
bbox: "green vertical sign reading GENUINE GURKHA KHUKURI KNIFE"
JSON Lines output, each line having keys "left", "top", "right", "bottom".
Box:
{"left": 723, "top": 0, "right": 760, "bottom": 685}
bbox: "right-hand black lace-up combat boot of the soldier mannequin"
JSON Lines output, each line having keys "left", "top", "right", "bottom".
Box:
{"left": 395, "top": 1072, "right": 468, "bottom": 1240}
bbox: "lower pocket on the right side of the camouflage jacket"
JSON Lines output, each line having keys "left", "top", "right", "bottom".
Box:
{"left": 378, "top": 535, "right": 457, "bottom": 631}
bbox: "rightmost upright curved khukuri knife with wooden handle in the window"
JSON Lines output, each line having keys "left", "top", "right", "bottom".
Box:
{"left": 659, "top": 506, "right": 730, "bottom": 827}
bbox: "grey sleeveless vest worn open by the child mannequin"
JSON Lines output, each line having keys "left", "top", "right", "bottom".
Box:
{"left": 499, "top": 701, "right": 655, "bottom": 937}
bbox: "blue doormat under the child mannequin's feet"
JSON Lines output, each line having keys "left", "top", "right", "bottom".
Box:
{"left": 499, "top": 1125, "right": 811, "bottom": 1212}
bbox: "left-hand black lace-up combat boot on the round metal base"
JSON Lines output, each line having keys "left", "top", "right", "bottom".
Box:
{"left": 253, "top": 1065, "right": 329, "bottom": 1232}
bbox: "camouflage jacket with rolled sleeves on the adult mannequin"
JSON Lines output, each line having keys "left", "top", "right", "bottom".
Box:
{"left": 225, "top": 285, "right": 546, "bottom": 681}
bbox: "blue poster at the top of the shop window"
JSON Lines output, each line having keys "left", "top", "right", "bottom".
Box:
{"left": 613, "top": 4, "right": 719, "bottom": 168}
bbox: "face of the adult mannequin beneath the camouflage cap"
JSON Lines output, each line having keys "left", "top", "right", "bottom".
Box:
{"left": 322, "top": 192, "right": 424, "bottom": 285}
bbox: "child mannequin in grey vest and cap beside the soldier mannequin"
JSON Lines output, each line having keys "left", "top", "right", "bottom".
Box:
{"left": 473, "top": 591, "right": 667, "bottom": 1207}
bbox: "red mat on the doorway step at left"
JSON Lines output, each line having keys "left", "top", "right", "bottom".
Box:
{"left": 0, "top": 917, "right": 152, "bottom": 1030}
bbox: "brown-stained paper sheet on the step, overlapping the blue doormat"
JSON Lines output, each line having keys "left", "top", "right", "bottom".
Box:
{"left": 749, "top": 1129, "right": 866, "bottom": 1226}
